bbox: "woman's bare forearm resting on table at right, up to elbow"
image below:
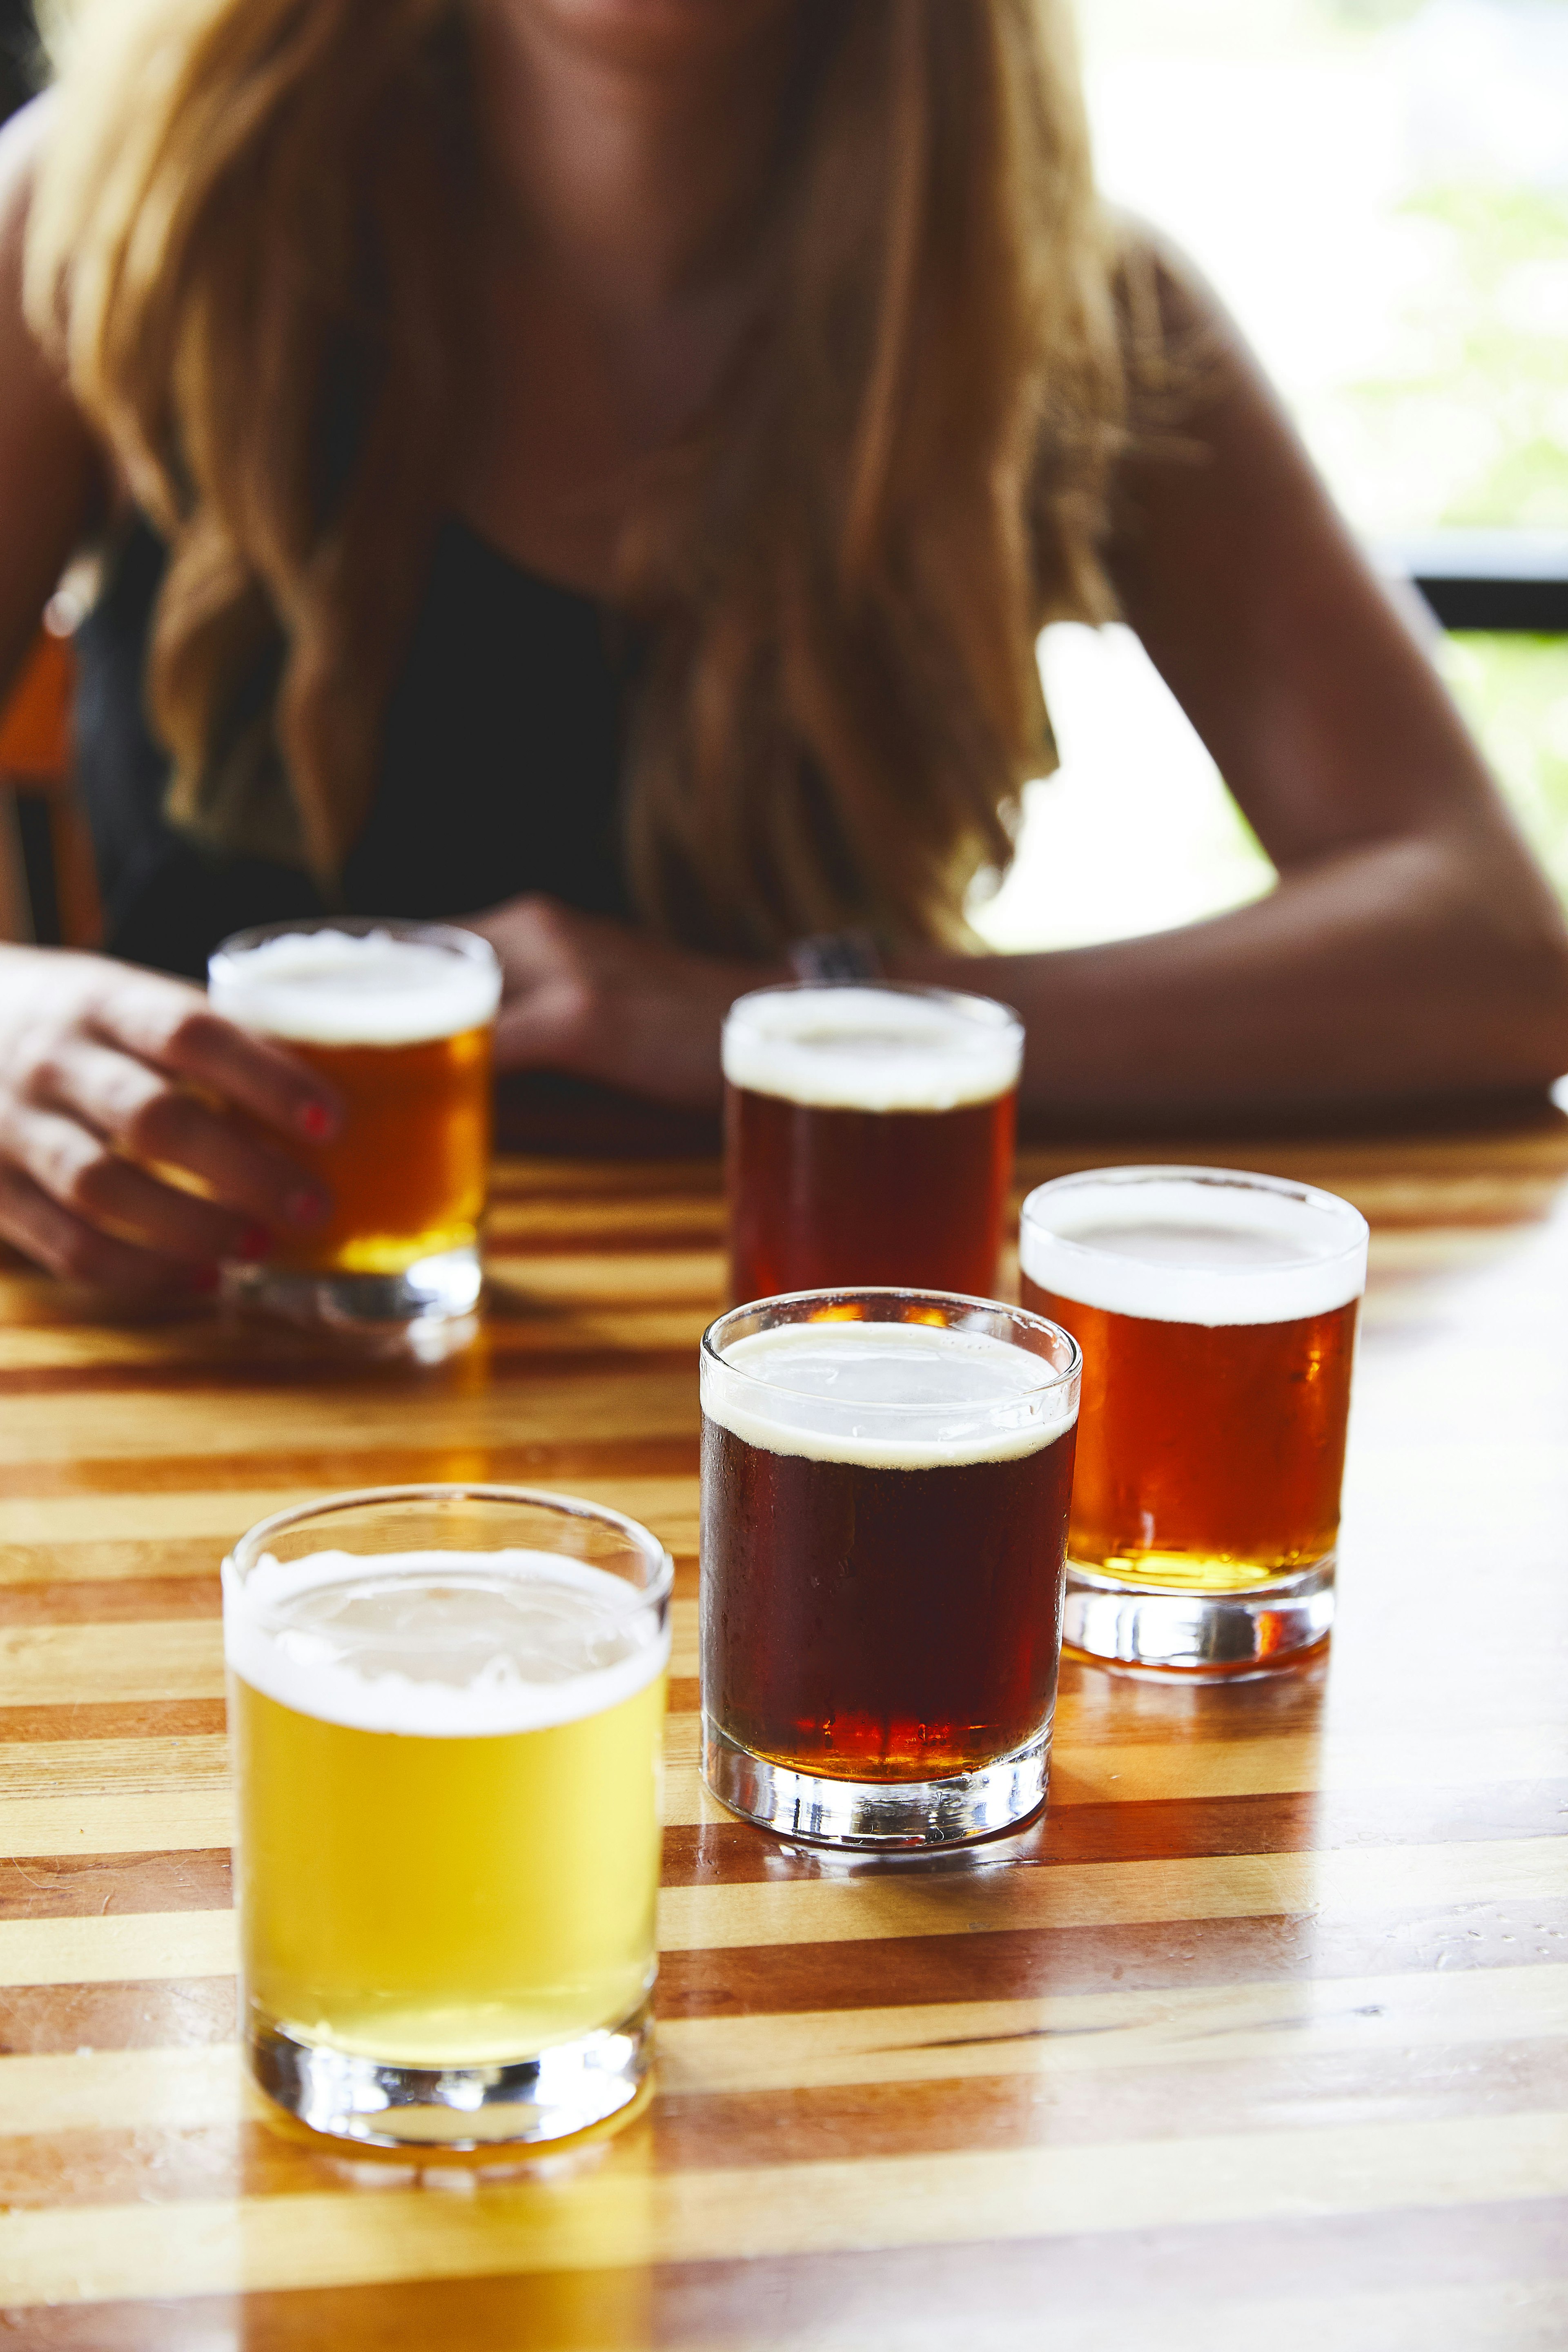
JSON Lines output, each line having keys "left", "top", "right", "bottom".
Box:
{"left": 895, "top": 835, "right": 1568, "bottom": 1120}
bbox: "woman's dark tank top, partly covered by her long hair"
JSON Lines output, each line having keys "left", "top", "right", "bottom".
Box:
{"left": 75, "top": 520, "right": 635, "bottom": 978}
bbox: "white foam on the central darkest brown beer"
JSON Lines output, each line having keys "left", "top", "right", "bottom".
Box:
{"left": 703, "top": 1322, "right": 1079, "bottom": 1470}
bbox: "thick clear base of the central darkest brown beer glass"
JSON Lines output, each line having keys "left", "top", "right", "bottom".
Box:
{"left": 703, "top": 1715, "right": 1051, "bottom": 1851}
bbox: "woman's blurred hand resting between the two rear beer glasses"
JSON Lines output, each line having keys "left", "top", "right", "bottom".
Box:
{"left": 468, "top": 898, "right": 790, "bottom": 1110}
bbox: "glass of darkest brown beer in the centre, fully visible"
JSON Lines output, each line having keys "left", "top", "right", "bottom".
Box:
{"left": 701, "top": 1289, "right": 1079, "bottom": 1846}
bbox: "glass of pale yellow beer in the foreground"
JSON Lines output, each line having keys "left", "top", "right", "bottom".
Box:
{"left": 223, "top": 1486, "right": 673, "bottom": 2147}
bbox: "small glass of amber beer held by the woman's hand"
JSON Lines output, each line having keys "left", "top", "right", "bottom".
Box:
{"left": 207, "top": 915, "right": 501, "bottom": 1329}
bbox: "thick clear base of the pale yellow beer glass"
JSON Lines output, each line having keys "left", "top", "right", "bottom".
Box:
{"left": 249, "top": 1999, "right": 653, "bottom": 2152}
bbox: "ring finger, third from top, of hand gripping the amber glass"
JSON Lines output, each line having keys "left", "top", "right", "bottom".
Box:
{"left": 5, "top": 1108, "right": 268, "bottom": 1265}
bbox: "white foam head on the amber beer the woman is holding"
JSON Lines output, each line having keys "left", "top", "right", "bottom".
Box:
{"left": 207, "top": 929, "right": 501, "bottom": 1044}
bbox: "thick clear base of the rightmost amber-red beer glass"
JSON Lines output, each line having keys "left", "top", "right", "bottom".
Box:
{"left": 1062, "top": 1552, "right": 1335, "bottom": 1682}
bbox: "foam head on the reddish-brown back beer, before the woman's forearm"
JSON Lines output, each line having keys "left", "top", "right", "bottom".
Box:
{"left": 724, "top": 983, "right": 1022, "bottom": 1110}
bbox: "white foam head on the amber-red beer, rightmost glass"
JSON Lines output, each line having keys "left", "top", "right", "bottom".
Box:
{"left": 1018, "top": 1167, "right": 1366, "bottom": 1329}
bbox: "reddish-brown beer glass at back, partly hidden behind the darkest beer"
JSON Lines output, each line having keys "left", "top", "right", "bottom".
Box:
{"left": 724, "top": 981, "right": 1022, "bottom": 1301}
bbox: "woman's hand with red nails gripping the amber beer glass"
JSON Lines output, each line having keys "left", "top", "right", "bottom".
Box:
{"left": 0, "top": 948, "right": 339, "bottom": 1298}
